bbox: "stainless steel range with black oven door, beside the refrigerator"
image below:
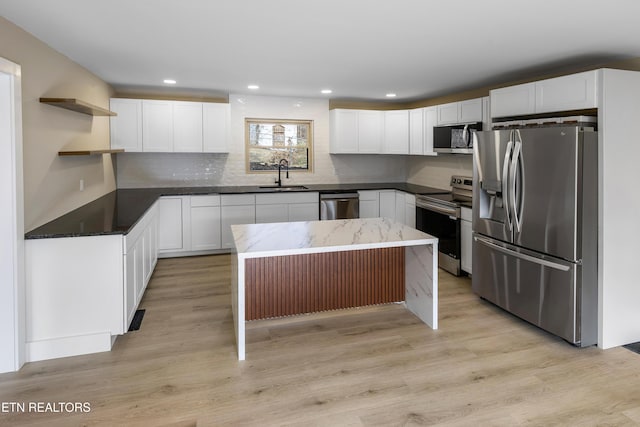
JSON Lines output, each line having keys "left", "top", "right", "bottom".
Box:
{"left": 416, "top": 175, "right": 473, "bottom": 276}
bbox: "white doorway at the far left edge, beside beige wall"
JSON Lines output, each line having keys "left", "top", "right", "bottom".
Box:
{"left": 0, "top": 58, "right": 26, "bottom": 372}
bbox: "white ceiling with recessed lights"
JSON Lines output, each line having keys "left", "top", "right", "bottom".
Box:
{"left": 0, "top": 0, "right": 640, "bottom": 101}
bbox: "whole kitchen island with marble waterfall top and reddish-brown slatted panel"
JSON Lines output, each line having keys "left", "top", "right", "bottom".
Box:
{"left": 231, "top": 218, "right": 438, "bottom": 360}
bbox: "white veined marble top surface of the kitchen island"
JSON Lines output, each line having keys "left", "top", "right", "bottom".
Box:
{"left": 231, "top": 218, "right": 438, "bottom": 258}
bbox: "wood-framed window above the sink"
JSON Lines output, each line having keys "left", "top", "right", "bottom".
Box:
{"left": 245, "top": 119, "right": 313, "bottom": 173}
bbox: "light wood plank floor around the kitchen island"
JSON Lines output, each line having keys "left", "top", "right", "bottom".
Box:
{"left": 0, "top": 255, "right": 640, "bottom": 426}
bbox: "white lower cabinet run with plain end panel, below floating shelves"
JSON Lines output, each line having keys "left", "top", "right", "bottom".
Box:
{"left": 25, "top": 204, "right": 158, "bottom": 362}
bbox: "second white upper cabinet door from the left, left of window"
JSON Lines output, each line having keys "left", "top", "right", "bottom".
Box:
{"left": 142, "top": 100, "right": 173, "bottom": 152}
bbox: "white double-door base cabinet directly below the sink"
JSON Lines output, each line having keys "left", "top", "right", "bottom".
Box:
{"left": 256, "top": 192, "right": 320, "bottom": 224}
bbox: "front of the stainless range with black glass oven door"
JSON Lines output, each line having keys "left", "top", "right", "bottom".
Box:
{"left": 416, "top": 200, "right": 461, "bottom": 276}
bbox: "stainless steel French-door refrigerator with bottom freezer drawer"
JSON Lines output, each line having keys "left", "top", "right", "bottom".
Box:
{"left": 471, "top": 126, "right": 598, "bottom": 347}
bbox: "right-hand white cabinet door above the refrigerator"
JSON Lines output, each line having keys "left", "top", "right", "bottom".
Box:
{"left": 536, "top": 70, "right": 598, "bottom": 113}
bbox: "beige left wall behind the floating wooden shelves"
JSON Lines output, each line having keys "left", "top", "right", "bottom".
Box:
{"left": 0, "top": 17, "right": 116, "bottom": 231}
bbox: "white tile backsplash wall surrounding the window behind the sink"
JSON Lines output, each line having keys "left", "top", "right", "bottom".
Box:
{"left": 117, "top": 95, "right": 406, "bottom": 188}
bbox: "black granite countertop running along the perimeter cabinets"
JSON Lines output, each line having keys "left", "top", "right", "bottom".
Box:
{"left": 25, "top": 182, "right": 449, "bottom": 239}
